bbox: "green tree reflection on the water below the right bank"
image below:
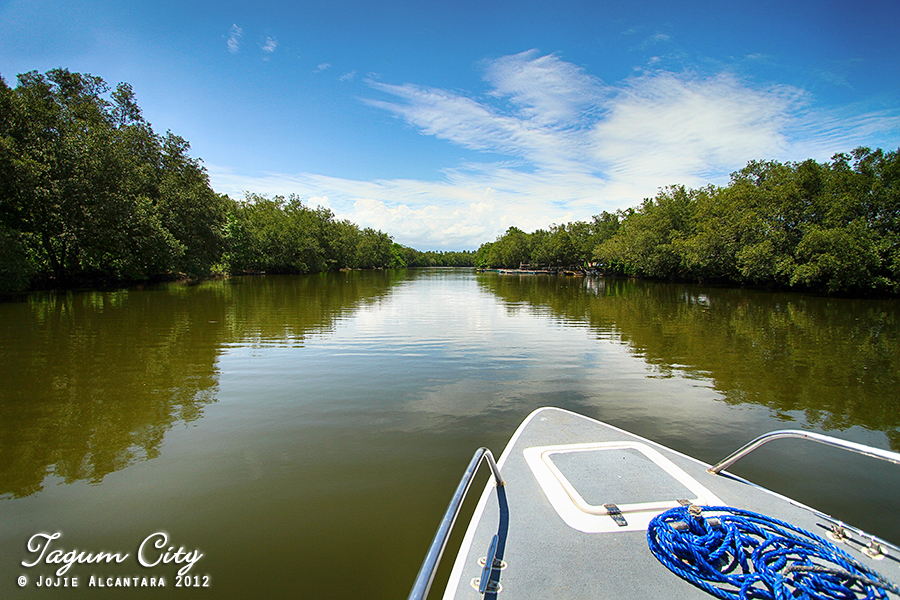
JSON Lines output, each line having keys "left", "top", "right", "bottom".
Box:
{"left": 479, "top": 275, "right": 900, "bottom": 450}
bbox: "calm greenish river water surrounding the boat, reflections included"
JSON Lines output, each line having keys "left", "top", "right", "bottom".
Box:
{"left": 0, "top": 269, "right": 900, "bottom": 599}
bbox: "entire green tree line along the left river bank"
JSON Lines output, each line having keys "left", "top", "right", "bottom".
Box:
{"left": 0, "top": 69, "right": 473, "bottom": 293}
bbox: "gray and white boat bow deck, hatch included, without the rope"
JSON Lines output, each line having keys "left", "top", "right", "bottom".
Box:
{"left": 444, "top": 408, "right": 900, "bottom": 600}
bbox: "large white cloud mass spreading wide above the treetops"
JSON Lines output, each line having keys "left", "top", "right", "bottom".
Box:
{"left": 210, "top": 51, "right": 900, "bottom": 249}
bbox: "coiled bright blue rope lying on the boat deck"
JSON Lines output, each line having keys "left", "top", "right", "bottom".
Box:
{"left": 647, "top": 506, "right": 900, "bottom": 600}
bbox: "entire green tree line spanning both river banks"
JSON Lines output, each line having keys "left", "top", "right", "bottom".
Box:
{"left": 0, "top": 69, "right": 900, "bottom": 294}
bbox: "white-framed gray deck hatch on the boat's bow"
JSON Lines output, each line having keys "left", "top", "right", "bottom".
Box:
{"left": 524, "top": 442, "right": 720, "bottom": 533}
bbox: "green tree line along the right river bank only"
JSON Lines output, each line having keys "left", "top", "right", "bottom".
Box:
{"left": 476, "top": 147, "right": 900, "bottom": 294}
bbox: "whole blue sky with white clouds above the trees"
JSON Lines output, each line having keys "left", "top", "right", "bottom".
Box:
{"left": 0, "top": 0, "right": 900, "bottom": 250}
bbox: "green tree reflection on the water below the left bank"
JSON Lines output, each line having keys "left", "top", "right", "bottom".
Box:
{"left": 0, "top": 272, "right": 398, "bottom": 498}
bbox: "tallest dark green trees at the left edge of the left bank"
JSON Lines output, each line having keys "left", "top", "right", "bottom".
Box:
{"left": 0, "top": 69, "right": 225, "bottom": 285}
